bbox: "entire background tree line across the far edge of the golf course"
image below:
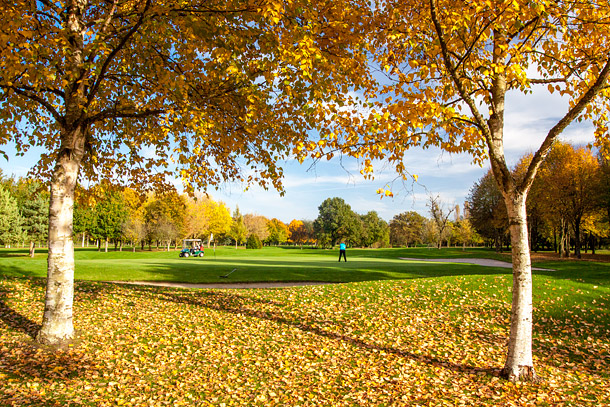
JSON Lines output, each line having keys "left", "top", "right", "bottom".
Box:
{"left": 0, "top": 142, "right": 610, "bottom": 257}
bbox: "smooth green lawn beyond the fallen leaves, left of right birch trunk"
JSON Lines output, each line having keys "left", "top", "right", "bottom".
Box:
{"left": 0, "top": 247, "right": 520, "bottom": 283}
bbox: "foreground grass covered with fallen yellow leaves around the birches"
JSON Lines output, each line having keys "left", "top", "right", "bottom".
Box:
{"left": 0, "top": 275, "right": 610, "bottom": 406}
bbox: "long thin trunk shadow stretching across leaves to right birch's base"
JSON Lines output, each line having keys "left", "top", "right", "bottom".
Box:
{"left": 161, "top": 291, "right": 501, "bottom": 377}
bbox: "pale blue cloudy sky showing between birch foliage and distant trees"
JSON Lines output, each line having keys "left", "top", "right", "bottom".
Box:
{"left": 0, "top": 89, "right": 593, "bottom": 223}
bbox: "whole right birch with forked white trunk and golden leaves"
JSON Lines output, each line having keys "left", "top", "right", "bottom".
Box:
{"left": 312, "top": 0, "right": 610, "bottom": 380}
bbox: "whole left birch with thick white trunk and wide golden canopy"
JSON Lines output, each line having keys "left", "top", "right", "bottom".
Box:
{"left": 0, "top": 0, "right": 366, "bottom": 344}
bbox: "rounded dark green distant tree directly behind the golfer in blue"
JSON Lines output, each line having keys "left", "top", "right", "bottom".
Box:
{"left": 313, "top": 198, "right": 362, "bottom": 246}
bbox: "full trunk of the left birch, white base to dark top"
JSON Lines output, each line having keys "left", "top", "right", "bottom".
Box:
{"left": 36, "top": 0, "right": 87, "bottom": 347}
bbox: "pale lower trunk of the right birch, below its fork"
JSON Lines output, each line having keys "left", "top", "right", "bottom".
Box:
{"left": 502, "top": 195, "right": 537, "bottom": 381}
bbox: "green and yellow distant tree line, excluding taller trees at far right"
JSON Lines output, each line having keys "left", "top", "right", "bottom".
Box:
{"left": 0, "top": 177, "right": 470, "bottom": 251}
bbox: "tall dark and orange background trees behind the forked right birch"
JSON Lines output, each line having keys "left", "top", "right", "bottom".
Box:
{"left": 467, "top": 142, "right": 610, "bottom": 258}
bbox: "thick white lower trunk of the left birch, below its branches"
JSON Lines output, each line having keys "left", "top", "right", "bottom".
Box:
{"left": 36, "top": 129, "right": 84, "bottom": 346}
